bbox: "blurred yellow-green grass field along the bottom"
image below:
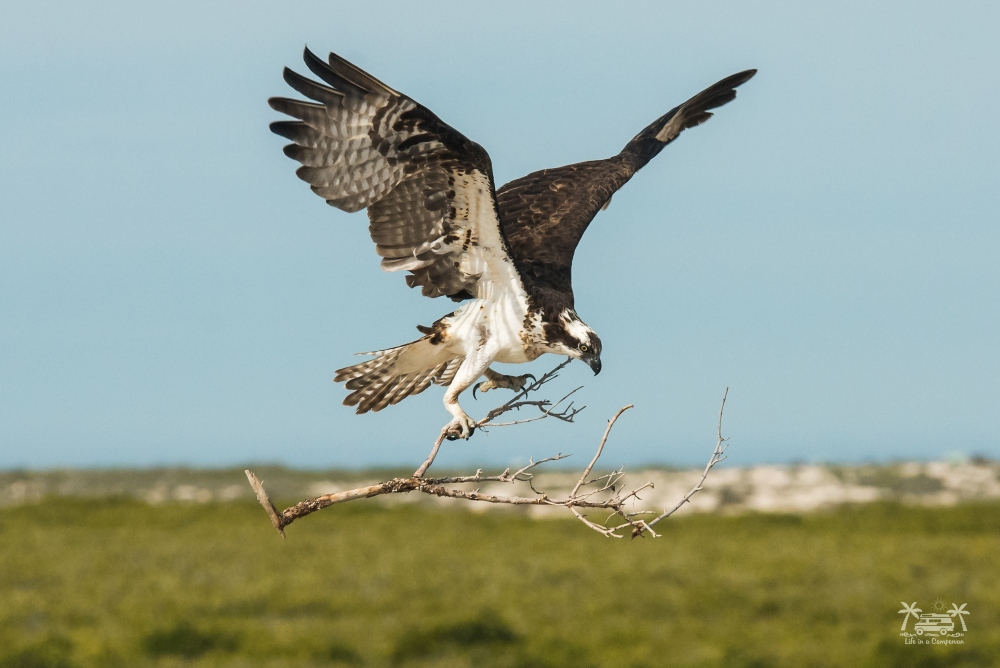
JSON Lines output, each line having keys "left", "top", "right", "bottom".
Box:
{"left": 0, "top": 499, "right": 1000, "bottom": 668}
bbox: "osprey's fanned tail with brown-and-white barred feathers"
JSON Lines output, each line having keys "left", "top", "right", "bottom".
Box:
{"left": 334, "top": 336, "right": 465, "bottom": 413}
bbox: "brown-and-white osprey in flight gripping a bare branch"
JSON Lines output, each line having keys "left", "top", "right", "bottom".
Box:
{"left": 268, "top": 48, "right": 756, "bottom": 438}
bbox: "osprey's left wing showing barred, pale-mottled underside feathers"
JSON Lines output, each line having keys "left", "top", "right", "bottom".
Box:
{"left": 268, "top": 49, "right": 506, "bottom": 300}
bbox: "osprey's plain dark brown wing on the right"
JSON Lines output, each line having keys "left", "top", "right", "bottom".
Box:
{"left": 497, "top": 70, "right": 757, "bottom": 299}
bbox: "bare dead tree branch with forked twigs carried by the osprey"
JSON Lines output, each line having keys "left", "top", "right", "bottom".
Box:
{"left": 246, "top": 368, "right": 729, "bottom": 538}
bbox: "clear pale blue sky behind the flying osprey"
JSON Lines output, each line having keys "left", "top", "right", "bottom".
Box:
{"left": 0, "top": 2, "right": 1000, "bottom": 467}
